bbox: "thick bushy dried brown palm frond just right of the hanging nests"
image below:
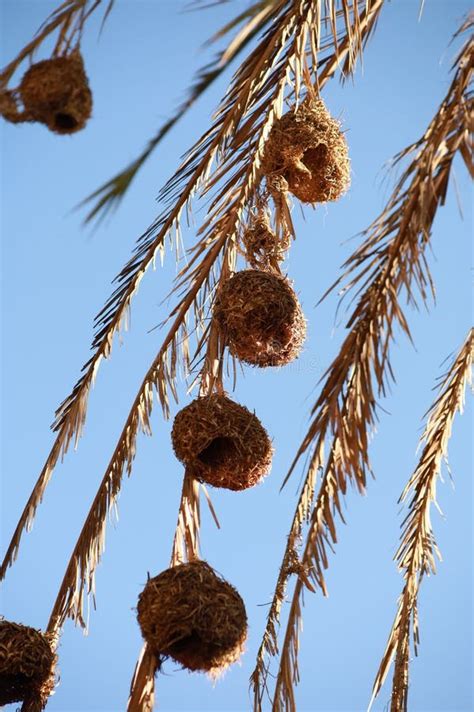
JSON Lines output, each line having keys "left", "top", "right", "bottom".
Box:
{"left": 251, "top": 18, "right": 474, "bottom": 712}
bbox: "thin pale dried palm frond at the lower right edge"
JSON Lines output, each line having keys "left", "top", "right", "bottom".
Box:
{"left": 369, "top": 329, "right": 474, "bottom": 712}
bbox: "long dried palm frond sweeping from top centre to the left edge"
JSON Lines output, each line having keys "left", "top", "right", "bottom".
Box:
{"left": 0, "top": 0, "right": 374, "bottom": 579}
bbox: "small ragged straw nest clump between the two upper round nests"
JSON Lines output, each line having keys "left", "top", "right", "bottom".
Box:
{"left": 242, "top": 214, "right": 291, "bottom": 271}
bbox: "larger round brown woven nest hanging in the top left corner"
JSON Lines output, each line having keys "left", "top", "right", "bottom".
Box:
{"left": 19, "top": 52, "right": 92, "bottom": 134}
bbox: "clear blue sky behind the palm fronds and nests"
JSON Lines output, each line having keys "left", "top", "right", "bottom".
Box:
{"left": 1, "top": 0, "right": 473, "bottom": 712}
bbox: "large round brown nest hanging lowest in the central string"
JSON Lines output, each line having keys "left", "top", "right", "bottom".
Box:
{"left": 137, "top": 561, "right": 247, "bottom": 675}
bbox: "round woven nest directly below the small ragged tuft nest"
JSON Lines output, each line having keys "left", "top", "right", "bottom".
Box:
{"left": 214, "top": 270, "right": 306, "bottom": 367}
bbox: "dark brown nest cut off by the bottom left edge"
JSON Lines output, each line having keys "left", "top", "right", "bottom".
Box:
{"left": 0, "top": 620, "right": 56, "bottom": 706}
